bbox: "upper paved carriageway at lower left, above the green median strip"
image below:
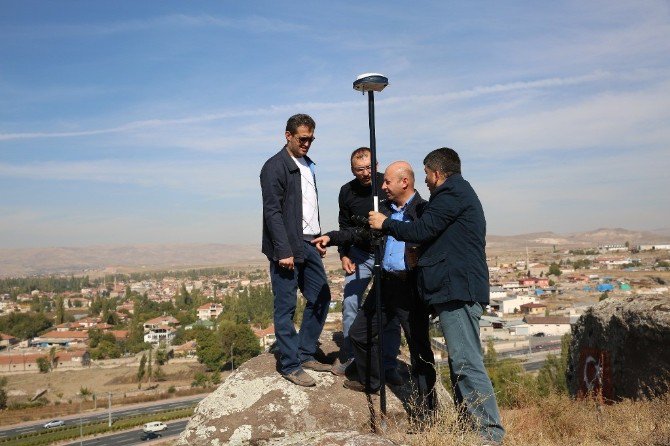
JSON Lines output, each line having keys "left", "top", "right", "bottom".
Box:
{"left": 0, "top": 395, "right": 206, "bottom": 439}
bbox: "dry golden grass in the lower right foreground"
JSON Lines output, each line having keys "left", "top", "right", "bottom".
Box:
{"left": 387, "top": 395, "right": 670, "bottom": 446}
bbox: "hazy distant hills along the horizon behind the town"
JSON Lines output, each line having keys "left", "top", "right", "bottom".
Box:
{"left": 0, "top": 228, "right": 670, "bottom": 277}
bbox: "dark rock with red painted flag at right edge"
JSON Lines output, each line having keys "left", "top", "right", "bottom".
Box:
{"left": 568, "top": 295, "right": 670, "bottom": 401}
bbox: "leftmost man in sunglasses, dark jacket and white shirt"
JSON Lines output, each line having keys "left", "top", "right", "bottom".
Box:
{"left": 260, "top": 114, "right": 331, "bottom": 387}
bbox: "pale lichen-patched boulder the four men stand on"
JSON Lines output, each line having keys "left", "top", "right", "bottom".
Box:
{"left": 178, "top": 333, "right": 448, "bottom": 446}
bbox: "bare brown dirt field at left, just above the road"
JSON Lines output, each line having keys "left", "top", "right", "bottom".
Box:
{"left": 5, "top": 362, "right": 209, "bottom": 404}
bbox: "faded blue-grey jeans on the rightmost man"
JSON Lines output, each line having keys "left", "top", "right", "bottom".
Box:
{"left": 435, "top": 300, "right": 505, "bottom": 442}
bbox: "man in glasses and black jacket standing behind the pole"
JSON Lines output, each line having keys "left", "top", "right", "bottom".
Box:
{"left": 332, "top": 147, "right": 402, "bottom": 385}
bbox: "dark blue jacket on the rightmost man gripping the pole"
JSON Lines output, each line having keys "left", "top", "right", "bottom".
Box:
{"left": 382, "top": 174, "right": 489, "bottom": 305}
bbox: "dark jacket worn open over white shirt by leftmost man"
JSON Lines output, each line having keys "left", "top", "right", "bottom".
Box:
{"left": 261, "top": 146, "right": 316, "bottom": 263}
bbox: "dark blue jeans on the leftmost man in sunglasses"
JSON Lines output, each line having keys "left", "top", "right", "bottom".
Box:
{"left": 270, "top": 242, "right": 330, "bottom": 375}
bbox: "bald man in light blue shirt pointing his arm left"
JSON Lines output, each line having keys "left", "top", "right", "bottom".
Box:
{"left": 312, "top": 161, "right": 436, "bottom": 412}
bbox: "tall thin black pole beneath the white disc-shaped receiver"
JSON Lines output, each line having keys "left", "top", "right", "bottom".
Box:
{"left": 368, "top": 90, "right": 386, "bottom": 416}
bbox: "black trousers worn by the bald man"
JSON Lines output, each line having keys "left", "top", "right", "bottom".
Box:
{"left": 349, "top": 273, "right": 436, "bottom": 409}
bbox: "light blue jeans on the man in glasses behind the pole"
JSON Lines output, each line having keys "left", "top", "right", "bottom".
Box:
{"left": 340, "top": 246, "right": 400, "bottom": 370}
